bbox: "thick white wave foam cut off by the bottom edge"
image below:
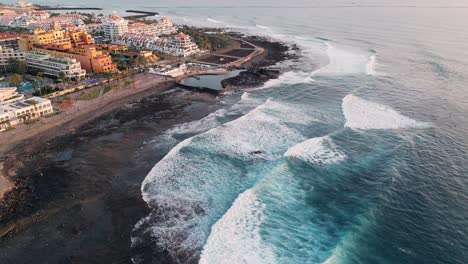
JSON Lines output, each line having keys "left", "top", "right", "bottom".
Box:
{"left": 199, "top": 189, "right": 275, "bottom": 264}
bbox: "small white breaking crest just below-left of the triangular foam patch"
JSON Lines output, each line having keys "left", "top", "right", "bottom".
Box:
{"left": 284, "top": 136, "right": 346, "bottom": 165}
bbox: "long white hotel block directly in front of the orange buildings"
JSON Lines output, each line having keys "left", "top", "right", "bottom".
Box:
{"left": 25, "top": 52, "right": 86, "bottom": 78}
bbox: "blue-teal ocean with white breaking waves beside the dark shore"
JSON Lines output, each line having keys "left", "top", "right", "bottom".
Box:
{"left": 8, "top": 0, "right": 468, "bottom": 264}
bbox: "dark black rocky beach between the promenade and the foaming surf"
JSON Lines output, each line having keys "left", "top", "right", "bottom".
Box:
{"left": 0, "top": 91, "right": 216, "bottom": 264}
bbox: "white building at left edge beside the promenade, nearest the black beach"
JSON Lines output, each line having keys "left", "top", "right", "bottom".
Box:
{"left": 0, "top": 97, "right": 54, "bottom": 131}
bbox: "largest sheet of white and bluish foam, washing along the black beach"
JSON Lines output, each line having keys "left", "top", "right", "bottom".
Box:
{"left": 135, "top": 97, "right": 314, "bottom": 258}
